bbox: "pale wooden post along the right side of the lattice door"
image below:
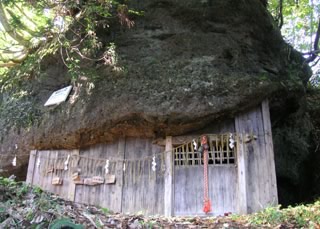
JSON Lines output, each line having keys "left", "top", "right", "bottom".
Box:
{"left": 236, "top": 133, "right": 248, "bottom": 214}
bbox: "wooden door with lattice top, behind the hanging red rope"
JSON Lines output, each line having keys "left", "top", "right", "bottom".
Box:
{"left": 173, "top": 134, "right": 237, "bottom": 216}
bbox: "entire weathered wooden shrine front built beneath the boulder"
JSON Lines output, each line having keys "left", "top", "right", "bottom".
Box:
{"left": 27, "top": 101, "right": 278, "bottom": 216}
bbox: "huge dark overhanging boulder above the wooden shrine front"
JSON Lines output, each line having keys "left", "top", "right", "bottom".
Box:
{"left": 1, "top": 0, "right": 308, "bottom": 196}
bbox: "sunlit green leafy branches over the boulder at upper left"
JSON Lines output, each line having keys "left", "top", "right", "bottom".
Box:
{"left": 0, "top": 0, "right": 136, "bottom": 83}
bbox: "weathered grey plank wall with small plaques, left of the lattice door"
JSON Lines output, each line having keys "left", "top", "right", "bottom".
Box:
{"left": 27, "top": 138, "right": 164, "bottom": 215}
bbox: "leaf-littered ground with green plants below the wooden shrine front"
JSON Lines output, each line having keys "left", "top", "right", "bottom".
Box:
{"left": 0, "top": 177, "right": 320, "bottom": 229}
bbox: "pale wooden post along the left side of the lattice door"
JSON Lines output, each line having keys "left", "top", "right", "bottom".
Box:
{"left": 164, "top": 136, "right": 174, "bottom": 216}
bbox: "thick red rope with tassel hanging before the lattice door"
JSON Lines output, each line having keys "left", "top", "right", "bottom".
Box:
{"left": 201, "top": 135, "right": 211, "bottom": 214}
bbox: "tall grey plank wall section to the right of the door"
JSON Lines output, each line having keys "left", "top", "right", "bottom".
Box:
{"left": 235, "top": 101, "right": 278, "bottom": 213}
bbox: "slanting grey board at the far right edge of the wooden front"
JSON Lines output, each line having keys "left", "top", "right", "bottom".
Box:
{"left": 261, "top": 99, "right": 278, "bottom": 204}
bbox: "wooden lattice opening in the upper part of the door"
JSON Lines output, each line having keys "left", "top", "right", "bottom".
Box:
{"left": 173, "top": 134, "right": 237, "bottom": 166}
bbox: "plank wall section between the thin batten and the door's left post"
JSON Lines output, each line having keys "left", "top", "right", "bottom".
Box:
{"left": 122, "top": 138, "right": 164, "bottom": 215}
